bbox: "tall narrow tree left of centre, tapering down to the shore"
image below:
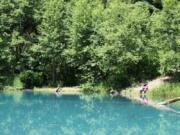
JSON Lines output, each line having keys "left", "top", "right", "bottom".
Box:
{"left": 33, "top": 0, "right": 71, "bottom": 85}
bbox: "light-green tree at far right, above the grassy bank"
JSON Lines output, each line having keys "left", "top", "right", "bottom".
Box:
{"left": 152, "top": 0, "right": 180, "bottom": 74}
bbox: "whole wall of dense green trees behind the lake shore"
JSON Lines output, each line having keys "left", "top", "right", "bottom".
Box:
{"left": 0, "top": 0, "right": 180, "bottom": 88}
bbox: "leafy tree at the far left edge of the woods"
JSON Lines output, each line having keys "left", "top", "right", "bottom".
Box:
{"left": 0, "top": 0, "right": 29, "bottom": 73}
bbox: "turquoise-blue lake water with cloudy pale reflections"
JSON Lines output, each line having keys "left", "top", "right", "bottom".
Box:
{"left": 0, "top": 92, "right": 180, "bottom": 135}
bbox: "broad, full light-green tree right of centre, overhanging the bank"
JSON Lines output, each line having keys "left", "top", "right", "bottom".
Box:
{"left": 93, "top": 1, "right": 158, "bottom": 87}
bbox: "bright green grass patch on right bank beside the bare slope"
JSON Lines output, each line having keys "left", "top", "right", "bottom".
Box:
{"left": 148, "top": 82, "right": 180, "bottom": 99}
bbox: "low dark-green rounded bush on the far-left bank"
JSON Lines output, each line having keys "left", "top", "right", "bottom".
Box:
{"left": 20, "top": 71, "right": 43, "bottom": 89}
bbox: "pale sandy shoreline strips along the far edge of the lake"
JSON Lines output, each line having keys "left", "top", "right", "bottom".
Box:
{"left": 3, "top": 83, "right": 180, "bottom": 114}
